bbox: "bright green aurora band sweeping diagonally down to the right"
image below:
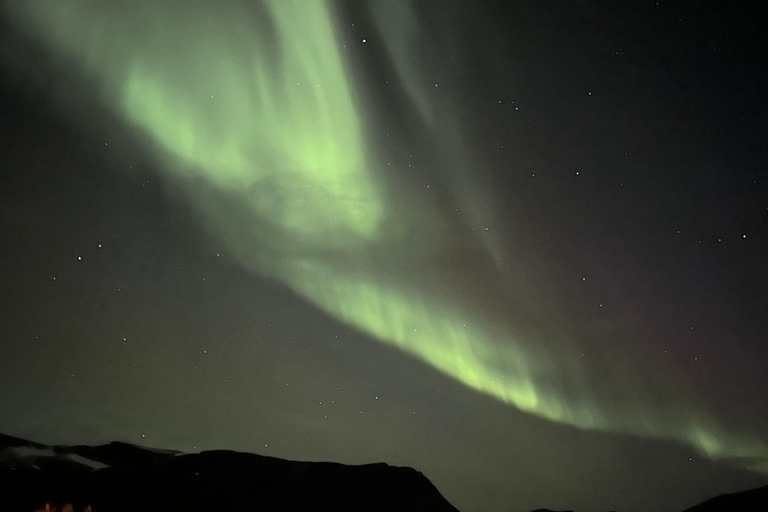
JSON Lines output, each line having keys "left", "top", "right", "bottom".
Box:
{"left": 5, "top": 0, "right": 768, "bottom": 470}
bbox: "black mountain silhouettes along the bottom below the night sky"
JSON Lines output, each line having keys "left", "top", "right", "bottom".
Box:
{"left": 0, "top": 434, "right": 768, "bottom": 512}
